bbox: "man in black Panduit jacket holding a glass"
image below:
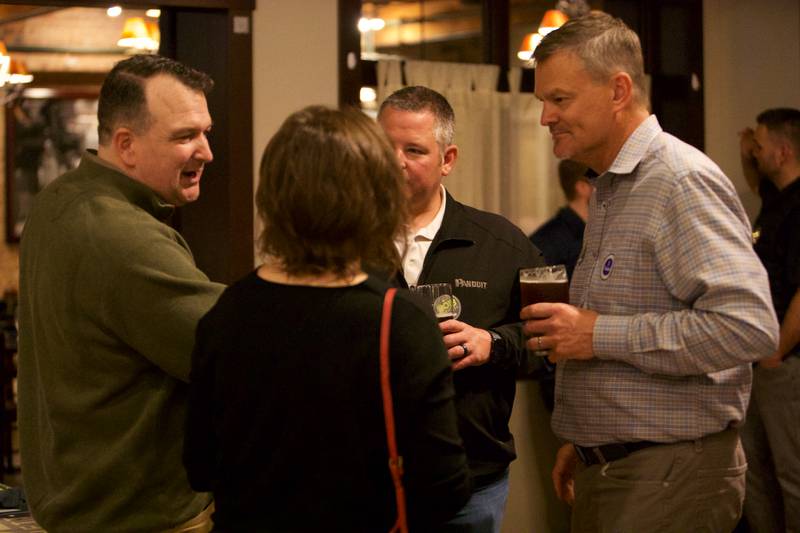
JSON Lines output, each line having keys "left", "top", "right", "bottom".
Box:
{"left": 378, "top": 87, "right": 544, "bottom": 533}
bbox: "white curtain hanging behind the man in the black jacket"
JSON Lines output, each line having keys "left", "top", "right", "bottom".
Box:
{"left": 377, "top": 60, "right": 564, "bottom": 234}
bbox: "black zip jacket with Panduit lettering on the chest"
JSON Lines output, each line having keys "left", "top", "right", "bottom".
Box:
{"left": 398, "top": 193, "right": 544, "bottom": 488}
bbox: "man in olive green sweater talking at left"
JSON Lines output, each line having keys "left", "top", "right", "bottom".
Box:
{"left": 19, "top": 56, "right": 223, "bottom": 533}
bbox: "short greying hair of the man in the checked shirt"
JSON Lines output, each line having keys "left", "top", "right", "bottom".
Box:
{"left": 533, "top": 11, "right": 650, "bottom": 109}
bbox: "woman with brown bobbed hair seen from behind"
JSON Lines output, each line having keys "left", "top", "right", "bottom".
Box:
{"left": 184, "top": 107, "right": 470, "bottom": 532}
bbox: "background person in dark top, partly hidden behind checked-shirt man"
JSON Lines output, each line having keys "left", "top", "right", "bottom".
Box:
{"left": 529, "top": 159, "right": 593, "bottom": 279}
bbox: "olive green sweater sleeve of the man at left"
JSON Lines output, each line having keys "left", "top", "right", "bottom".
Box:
{"left": 82, "top": 219, "right": 224, "bottom": 381}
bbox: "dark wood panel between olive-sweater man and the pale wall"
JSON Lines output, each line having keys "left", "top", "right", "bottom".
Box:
{"left": 170, "top": 8, "right": 253, "bottom": 283}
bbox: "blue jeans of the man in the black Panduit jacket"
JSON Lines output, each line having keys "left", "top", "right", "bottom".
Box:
{"left": 441, "top": 469, "right": 508, "bottom": 533}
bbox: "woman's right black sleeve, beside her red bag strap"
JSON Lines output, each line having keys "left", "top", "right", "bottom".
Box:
{"left": 390, "top": 295, "right": 471, "bottom": 531}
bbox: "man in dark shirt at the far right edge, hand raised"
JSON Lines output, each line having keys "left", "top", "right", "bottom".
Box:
{"left": 740, "top": 108, "right": 800, "bottom": 533}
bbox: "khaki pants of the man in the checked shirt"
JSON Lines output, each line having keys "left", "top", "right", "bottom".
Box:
{"left": 572, "top": 429, "right": 747, "bottom": 533}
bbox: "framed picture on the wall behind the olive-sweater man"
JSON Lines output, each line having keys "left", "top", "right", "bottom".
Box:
{"left": 5, "top": 86, "right": 100, "bottom": 242}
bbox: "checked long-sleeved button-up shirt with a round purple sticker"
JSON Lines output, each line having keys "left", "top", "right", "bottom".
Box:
{"left": 553, "top": 115, "right": 778, "bottom": 446}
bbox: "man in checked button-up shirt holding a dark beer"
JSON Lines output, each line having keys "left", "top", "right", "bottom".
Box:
{"left": 522, "top": 13, "right": 778, "bottom": 532}
